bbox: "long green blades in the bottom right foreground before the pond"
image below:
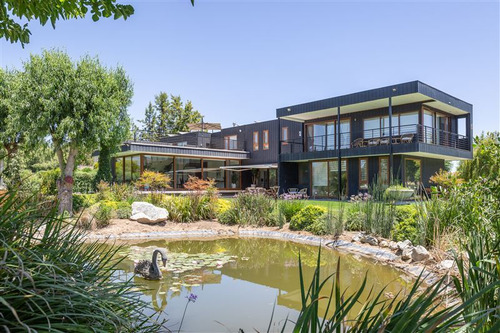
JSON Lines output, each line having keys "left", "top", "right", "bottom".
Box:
{"left": 283, "top": 249, "right": 500, "bottom": 333}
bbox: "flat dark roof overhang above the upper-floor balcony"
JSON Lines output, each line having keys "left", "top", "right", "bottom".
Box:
{"left": 276, "top": 81, "right": 472, "bottom": 122}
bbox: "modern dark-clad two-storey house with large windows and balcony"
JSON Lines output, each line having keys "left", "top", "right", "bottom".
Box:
{"left": 113, "top": 81, "right": 472, "bottom": 198}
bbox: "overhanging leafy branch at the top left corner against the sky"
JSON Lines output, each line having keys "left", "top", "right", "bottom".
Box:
{"left": 0, "top": 0, "right": 134, "bottom": 46}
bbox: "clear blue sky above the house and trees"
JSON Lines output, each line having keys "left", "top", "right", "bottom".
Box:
{"left": 0, "top": 0, "right": 500, "bottom": 133}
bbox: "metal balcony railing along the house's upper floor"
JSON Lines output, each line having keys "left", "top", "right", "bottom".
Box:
{"left": 281, "top": 124, "right": 470, "bottom": 154}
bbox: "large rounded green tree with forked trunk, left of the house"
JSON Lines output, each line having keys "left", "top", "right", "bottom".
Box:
{"left": 14, "top": 51, "right": 132, "bottom": 214}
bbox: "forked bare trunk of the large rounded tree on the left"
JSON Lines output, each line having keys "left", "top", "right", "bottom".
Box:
{"left": 57, "top": 148, "right": 78, "bottom": 216}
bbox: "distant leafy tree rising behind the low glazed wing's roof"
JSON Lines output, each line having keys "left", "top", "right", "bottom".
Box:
{"left": 140, "top": 92, "right": 201, "bottom": 140}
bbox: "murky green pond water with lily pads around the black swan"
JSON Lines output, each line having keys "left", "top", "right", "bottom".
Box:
{"left": 114, "top": 238, "right": 410, "bottom": 332}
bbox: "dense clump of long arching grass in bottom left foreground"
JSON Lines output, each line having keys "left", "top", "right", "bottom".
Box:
{"left": 0, "top": 192, "right": 163, "bottom": 332}
